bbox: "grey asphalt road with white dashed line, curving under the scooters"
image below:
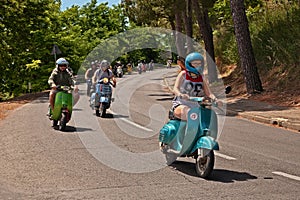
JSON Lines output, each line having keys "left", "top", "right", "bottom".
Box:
{"left": 0, "top": 69, "right": 300, "bottom": 199}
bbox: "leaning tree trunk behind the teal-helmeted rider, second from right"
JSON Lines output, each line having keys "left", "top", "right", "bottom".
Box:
{"left": 192, "top": 0, "right": 218, "bottom": 83}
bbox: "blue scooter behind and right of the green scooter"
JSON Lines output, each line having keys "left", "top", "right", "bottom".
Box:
{"left": 90, "top": 78, "right": 113, "bottom": 117}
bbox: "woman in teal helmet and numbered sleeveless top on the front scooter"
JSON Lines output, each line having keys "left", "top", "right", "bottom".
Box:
{"left": 172, "top": 52, "right": 222, "bottom": 120}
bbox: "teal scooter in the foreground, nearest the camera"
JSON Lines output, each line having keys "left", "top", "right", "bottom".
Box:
{"left": 159, "top": 87, "right": 231, "bottom": 178}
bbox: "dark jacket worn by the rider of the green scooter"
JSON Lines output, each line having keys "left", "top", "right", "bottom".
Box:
{"left": 48, "top": 67, "right": 75, "bottom": 87}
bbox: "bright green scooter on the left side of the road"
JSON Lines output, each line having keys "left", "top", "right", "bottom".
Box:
{"left": 50, "top": 86, "right": 74, "bottom": 131}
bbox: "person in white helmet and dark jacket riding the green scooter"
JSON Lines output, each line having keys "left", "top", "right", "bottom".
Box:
{"left": 48, "top": 58, "right": 79, "bottom": 116}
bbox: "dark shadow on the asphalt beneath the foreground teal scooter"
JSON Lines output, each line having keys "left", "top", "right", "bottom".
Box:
{"left": 171, "top": 161, "right": 257, "bottom": 183}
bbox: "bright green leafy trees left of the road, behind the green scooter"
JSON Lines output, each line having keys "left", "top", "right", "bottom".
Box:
{"left": 0, "top": 0, "right": 127, "bottom": 99}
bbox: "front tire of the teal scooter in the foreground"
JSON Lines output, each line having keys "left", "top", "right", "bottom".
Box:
{"left": 196, "top": 150, "right": 215, "bottom": 178}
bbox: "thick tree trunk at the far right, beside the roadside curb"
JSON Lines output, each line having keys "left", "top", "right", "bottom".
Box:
{"left": 230, "top": 0, "right": 263, "bottom": 94}
